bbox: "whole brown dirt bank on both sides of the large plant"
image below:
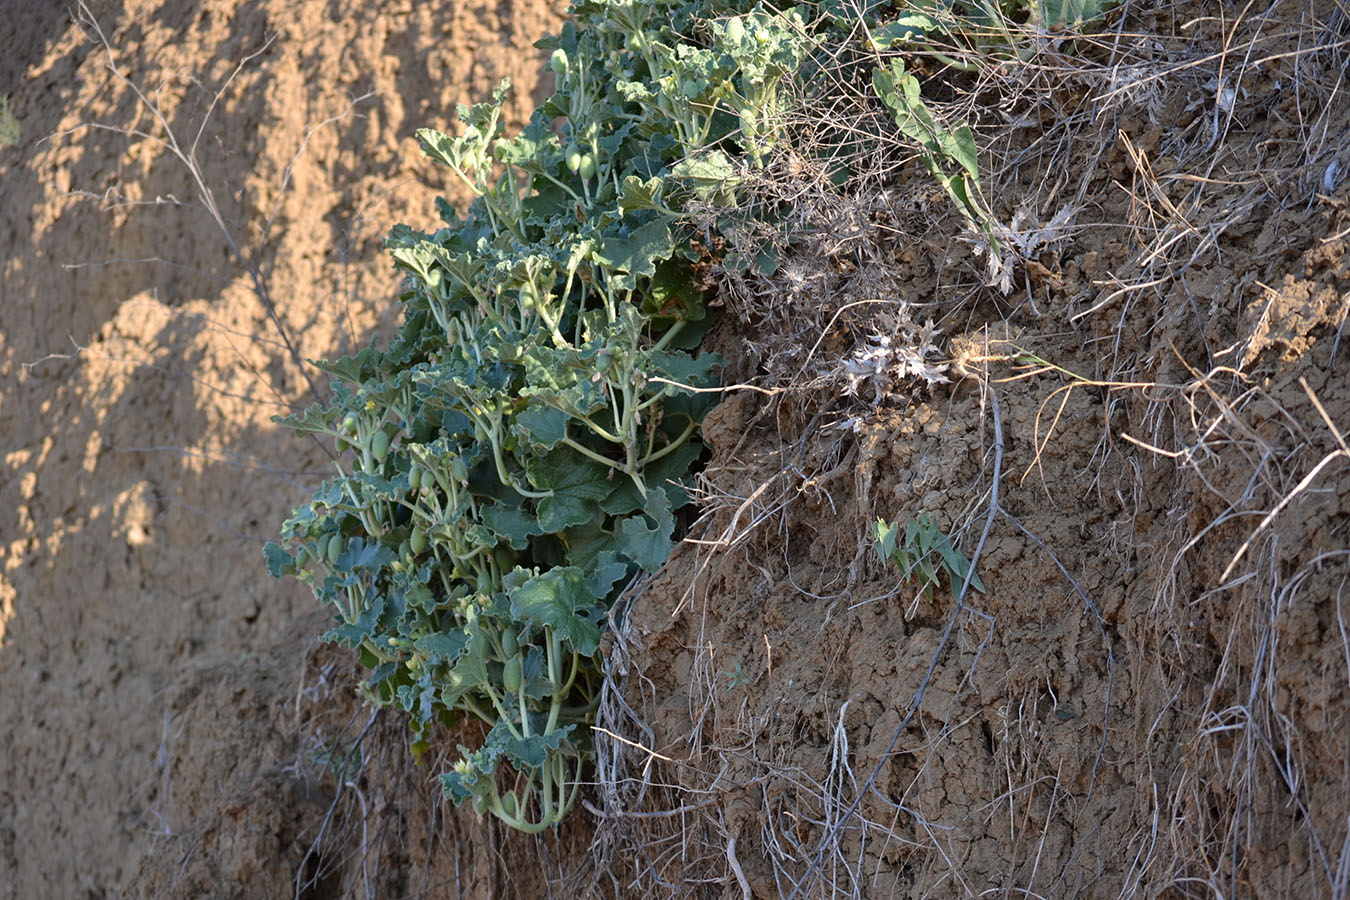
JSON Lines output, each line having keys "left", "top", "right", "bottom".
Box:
{"left": 0, "top": 0, "right": 1350, "bottom": 899}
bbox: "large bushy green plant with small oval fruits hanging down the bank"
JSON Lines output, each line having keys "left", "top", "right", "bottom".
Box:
{"left": 266, "top": 0, "right": 805, "bottom": 831}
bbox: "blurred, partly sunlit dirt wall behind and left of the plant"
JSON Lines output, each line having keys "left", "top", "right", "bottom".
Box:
{"left": 0, "top": 0, "right": 560, "bottom": 897}
